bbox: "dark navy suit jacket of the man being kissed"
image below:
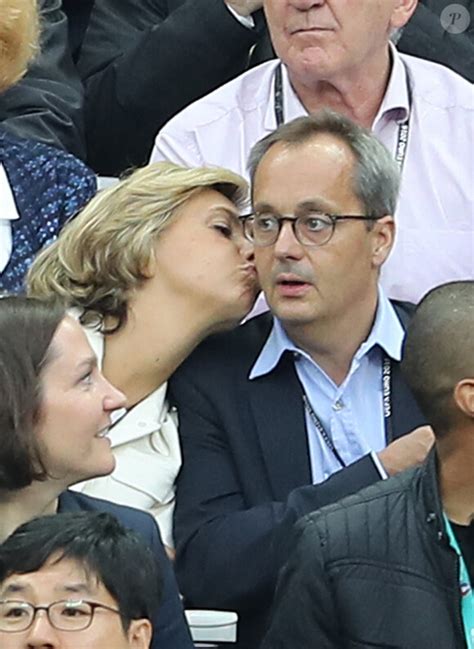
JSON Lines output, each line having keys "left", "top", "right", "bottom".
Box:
{"left": 170, "top": 312, "right": 425, "bottom": 649}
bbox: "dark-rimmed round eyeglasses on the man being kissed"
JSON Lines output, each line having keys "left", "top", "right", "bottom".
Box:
{"left": 239, "top": 211, "right": 382, "bottom": 247}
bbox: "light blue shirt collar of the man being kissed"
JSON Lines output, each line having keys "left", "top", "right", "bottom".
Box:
{"left": 249, "top": 287, "right": 405, "bottom": 380}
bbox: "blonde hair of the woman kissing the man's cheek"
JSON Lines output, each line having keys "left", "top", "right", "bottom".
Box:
{"left": 27, "top": 162, "right": 248, "bottom": 333}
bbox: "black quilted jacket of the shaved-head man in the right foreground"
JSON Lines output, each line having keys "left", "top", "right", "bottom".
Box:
{"left": 262, "top": 451, "right": 467, "bottom": 649}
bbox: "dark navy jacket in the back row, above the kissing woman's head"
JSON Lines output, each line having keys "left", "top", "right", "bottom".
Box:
{"left": 74, "top": 0, "right": 266, "bottom": 175}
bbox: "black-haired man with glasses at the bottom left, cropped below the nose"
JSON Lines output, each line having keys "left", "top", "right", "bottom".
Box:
{"left": 0, "top": 512, "right": 161, "bottom": 649}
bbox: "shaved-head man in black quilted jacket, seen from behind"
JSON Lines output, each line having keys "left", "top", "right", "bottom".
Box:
{"left": 263, "top": 281, "right": 474, "bottom": 649}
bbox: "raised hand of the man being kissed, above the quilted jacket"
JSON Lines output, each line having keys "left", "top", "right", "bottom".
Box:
{"left": 377, "top": 426, "right": 434, "bottom": 476}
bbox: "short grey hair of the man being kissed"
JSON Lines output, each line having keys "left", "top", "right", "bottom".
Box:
{"left": 248, "top": 109, "right": 400, "bottom": 216}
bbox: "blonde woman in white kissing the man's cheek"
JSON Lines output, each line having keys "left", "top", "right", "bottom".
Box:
{"left": 28, "top": 163, "right": 256, "bottom": 546}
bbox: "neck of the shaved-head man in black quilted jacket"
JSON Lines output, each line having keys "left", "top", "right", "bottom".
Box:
{"left": 436, "top": 422, "right": 474, "bottom": 525}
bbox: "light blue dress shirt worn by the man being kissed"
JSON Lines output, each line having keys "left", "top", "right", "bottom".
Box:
{"left": 249, "top": 289, "right": 405, "bottom": 484}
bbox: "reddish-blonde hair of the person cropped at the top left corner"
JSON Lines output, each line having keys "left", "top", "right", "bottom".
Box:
{"left": 0, "top": 0, "right": 39, "bottom": 92}
